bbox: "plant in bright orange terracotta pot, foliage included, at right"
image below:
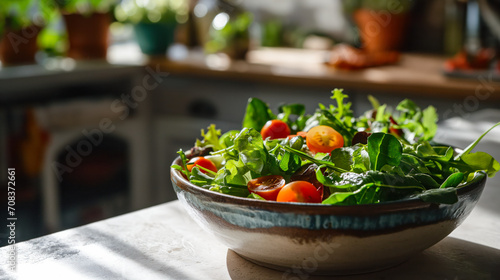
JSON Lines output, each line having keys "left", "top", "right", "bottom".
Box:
{"left": 343, "top": 0, "right": 413, "bottom": 52}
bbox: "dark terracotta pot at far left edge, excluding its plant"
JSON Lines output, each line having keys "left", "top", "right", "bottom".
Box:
{"left": 0, "top": 25, "right": 41, "bottom": 65}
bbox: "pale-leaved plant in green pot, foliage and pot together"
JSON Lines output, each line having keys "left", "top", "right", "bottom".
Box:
{"left": 115, "top": 0, "right": 188, "bottom": 55}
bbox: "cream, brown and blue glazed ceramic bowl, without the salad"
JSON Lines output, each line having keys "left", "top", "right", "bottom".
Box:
{"left": 171, "top": 159, "right": 486, "bottom": 275}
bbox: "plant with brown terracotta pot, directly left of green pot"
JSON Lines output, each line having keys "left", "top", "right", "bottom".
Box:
{"left": 55, "top": 0, "right": 116, "bottom": 59}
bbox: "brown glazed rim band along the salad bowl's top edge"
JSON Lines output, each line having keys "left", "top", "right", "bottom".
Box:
{"left": 170, "top": 157, "right": 487, "bottom": 210}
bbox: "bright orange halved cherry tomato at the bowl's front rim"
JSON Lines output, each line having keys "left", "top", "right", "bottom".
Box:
{"left": 276, "top": 181, "right": 321, "bottom": 203}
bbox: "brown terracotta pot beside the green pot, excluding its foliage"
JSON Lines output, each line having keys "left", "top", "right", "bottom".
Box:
{"left": 63, "top": 13, "right": 111, "bottom": 59}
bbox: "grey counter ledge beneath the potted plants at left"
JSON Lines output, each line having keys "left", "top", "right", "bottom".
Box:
{"left": 0, "top": 60, "right": 143, "bottom": 105}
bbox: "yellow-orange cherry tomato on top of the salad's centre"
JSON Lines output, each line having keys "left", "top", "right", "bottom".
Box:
{"left": 306, "top": 125, "right": 344, "bottom": 153}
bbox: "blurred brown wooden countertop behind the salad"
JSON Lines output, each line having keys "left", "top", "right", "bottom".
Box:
{"left": 149, "top": 48, "right": 500, "bottom": 100}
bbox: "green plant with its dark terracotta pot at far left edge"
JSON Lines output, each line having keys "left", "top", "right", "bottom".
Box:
{"left": 0, "top": 0, "right": 56, "bottom": 65}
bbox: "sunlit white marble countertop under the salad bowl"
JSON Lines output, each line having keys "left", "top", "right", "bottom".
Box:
{"left": 0, "top": 117, "right": 500, "bottom": 280}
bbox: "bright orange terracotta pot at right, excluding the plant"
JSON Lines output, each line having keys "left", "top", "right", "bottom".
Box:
{"left": 353, "top": 9, "right": 409, "bottom": 52}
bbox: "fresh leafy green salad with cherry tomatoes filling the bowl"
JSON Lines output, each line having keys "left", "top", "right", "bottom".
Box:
{"left": 172, "top": 89, "right": 500, "bottom": 205}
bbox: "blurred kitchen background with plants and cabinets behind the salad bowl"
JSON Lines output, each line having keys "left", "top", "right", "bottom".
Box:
{"left": 0, "top": 0, "right": 500, "bottom": 246}
